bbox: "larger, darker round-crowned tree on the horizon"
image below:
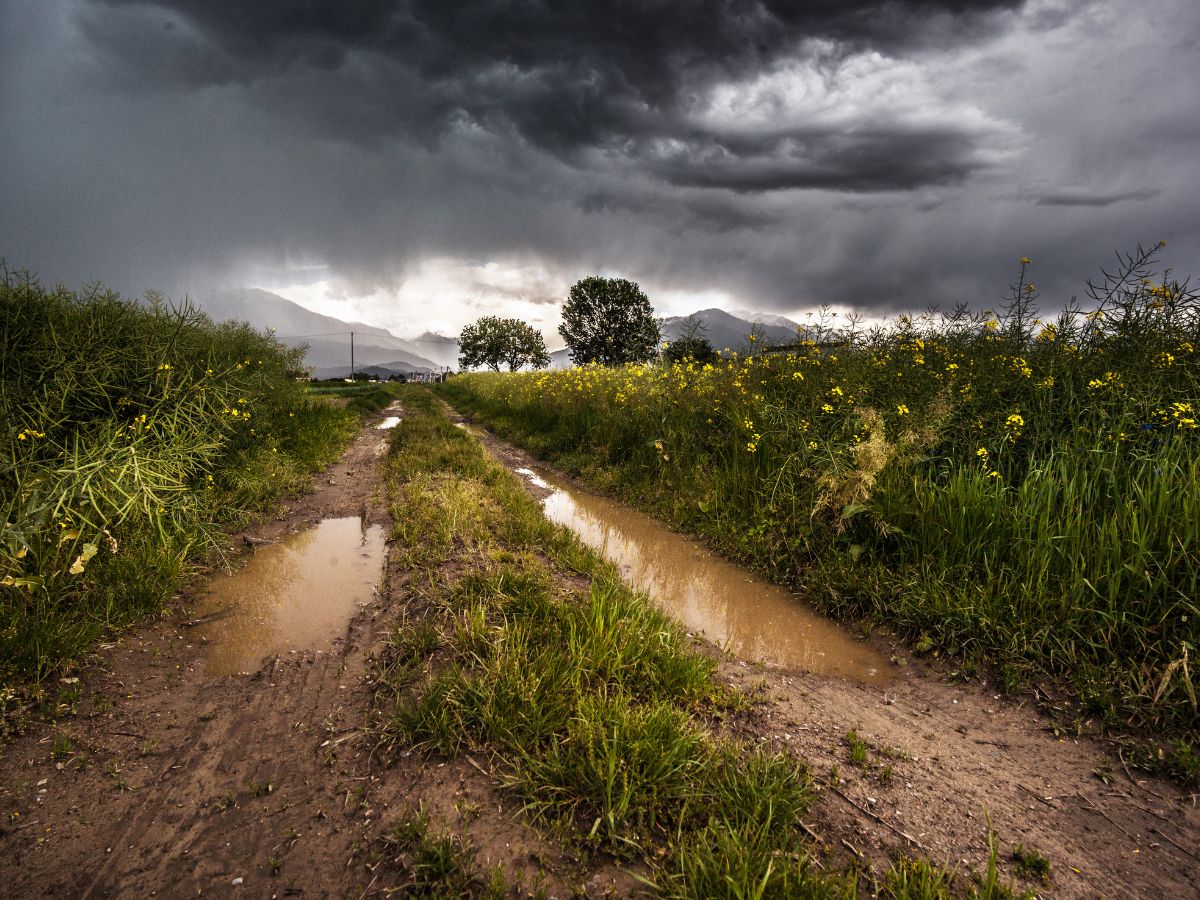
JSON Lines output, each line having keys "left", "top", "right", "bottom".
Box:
{"left": 558, "top": 275, "right": 659, "bottom": 366}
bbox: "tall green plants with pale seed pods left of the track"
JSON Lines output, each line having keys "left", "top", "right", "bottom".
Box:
{"left": 0, "top": 271, "right": 358, "bottom": 706}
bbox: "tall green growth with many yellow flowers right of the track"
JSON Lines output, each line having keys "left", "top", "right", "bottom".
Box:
{"left": 443, "top": 247, "right": 1200, "bottom": 748}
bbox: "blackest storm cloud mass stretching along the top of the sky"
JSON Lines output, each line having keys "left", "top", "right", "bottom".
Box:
{"left": 84, "top": 0, "right": 1022, "bottom": 192}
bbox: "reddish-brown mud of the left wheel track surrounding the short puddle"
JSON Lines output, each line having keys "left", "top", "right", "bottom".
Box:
{"left": 0, "top": 409, "right": 630, "bottom": 898}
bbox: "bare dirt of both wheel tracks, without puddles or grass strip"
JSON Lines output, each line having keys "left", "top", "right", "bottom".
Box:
{"left": 0, "top": 410, "right": 1200, "bottom": 896}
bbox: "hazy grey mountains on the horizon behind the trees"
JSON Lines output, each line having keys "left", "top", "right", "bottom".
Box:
{"left": 196, "top": 288, "right": 798, "bottom": 378}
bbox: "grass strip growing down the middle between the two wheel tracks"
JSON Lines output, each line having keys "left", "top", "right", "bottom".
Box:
{"left": 376, "top": 389, "right": 854, "bottom": 896}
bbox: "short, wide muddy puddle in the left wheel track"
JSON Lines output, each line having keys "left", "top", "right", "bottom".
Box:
{"left": 194, "top": 516, "right": 385, "bottom": 674}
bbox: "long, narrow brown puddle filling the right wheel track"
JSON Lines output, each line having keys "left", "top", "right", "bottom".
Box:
{"left": 516, "top": 468, "right": 890, "bottom": 684}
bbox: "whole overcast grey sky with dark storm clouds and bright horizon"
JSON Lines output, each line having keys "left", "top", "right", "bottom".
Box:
{"left": 0, "top": 0, "right": 1200, "bottom": 338}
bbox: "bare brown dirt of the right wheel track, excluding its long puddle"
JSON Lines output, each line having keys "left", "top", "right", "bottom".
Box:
{"left": 473, "top": 415, "right": 1200, "bottom": 898}
